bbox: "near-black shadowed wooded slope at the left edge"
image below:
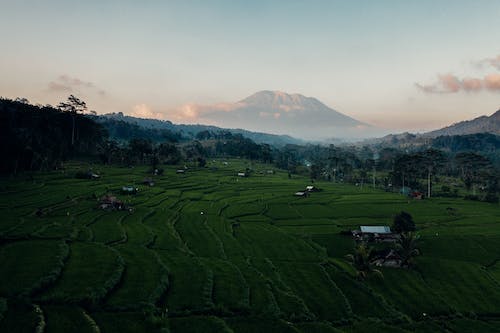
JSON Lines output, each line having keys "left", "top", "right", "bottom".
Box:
{"left": 0, "top": 99, "right": 107, "bottom": 173}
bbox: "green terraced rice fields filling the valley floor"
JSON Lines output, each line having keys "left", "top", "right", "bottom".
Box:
{"left": 0, "top": 160, "right": 500, "bottom": 333}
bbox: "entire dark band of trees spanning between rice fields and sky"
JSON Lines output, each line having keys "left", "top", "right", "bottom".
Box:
{"left": 0, "top": 96, "right": 500, "bottom": 201}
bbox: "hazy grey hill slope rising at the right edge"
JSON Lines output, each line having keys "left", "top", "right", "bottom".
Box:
{"left": 424, "top": 110, "right": 500, "bottom": 138}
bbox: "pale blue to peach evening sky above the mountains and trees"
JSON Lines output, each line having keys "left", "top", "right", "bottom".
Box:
{"left": 0, "top": 0, "right": 500, "bottom": 131}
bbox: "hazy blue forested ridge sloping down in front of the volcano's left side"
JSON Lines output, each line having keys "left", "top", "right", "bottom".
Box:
{"left": 93, "top": 112, "right": 304, "bottom": 147}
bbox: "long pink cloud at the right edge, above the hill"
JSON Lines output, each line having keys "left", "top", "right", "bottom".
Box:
{"left": 415, "top": 73, "right": 500, "bottom": 94}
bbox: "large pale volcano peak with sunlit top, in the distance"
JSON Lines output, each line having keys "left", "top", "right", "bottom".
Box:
{"left": 193, "top": 90, "right": 375, "bottom": 140}
